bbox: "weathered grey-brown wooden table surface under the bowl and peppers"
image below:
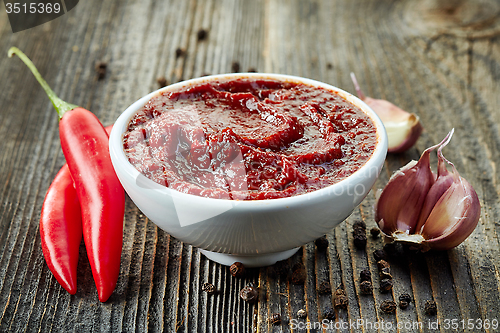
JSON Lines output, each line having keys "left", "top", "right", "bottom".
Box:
{"left": 0, "top": 0, "right": 500, "bottom": 332}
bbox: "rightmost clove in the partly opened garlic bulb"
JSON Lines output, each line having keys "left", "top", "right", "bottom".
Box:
{"left": 422, "top": 173, "right": 481, "bottom": 250}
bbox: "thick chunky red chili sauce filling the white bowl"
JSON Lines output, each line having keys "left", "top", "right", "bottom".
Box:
{"left": 123, "top": 79, "right": 377, "bottom": 200}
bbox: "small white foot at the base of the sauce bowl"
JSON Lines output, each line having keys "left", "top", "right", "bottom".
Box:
{"left": 200, "top": 247, "right": 300, "bottom": 267}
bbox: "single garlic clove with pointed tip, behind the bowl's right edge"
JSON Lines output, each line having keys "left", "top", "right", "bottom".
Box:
{"left": 351, "top": 73, "right": 423, "bottom": 153}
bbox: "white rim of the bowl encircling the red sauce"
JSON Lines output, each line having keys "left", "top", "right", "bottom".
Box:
{"left": 109, "top": 73, "right": 388, "bottom": 208}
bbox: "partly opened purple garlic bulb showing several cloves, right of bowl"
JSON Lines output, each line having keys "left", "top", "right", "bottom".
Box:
{"left": 375, "top": 130, "right": 481, "bottom": 251}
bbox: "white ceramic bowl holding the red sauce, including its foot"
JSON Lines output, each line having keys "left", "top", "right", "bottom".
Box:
{"left": 109, "top": 73, "right": 387, "bottom": 267}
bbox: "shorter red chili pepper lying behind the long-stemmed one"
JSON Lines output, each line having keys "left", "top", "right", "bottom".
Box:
{"left": 40, "top": 126, "right": 113, "bottom": 295}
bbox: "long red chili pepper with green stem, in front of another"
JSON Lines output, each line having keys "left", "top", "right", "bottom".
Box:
{"left": 8, "top": 47, "right": 125, "bottom": 302}
